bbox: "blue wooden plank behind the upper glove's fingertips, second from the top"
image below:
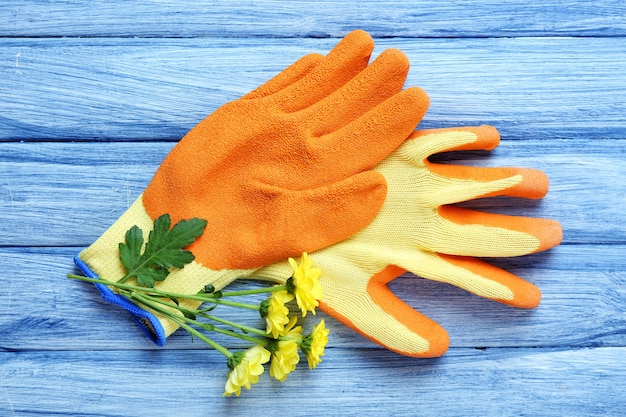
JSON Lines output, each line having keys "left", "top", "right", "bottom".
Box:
{"left": 0, "top": 36, "right": 626, "bottom": 141}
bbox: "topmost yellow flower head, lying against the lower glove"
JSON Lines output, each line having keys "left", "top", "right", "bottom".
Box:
{"left": 288, "top": 252, "right": 322, "bottom": 317}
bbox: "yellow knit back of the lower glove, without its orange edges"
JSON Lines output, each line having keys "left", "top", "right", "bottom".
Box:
{"left": 256, "top": 130, "right": 552, "bottom": 356}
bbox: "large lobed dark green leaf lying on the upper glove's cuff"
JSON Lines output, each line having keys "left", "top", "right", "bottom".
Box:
{"left": 119, "top": 214, "right": 207, "bottom": 288}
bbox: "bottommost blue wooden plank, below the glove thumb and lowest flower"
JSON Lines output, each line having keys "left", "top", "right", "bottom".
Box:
{"left": 0, "top": 348, "right": 626, "bottom": 417}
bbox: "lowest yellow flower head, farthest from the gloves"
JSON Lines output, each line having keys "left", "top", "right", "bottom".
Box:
{"left": 224, "top": 345, "right": 270, "bottom": 397}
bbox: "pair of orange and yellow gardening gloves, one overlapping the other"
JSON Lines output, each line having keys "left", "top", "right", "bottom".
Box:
{"left": 76, "top": 31, "right": 562, "bottom": 357}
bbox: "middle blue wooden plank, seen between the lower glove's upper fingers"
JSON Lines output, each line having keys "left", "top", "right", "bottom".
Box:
{"left": 0, "top": 137, "right": 626, "bottom": 246}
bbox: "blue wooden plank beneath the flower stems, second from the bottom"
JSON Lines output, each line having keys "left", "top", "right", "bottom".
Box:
{"left": 0, "top": 245, "right": 626, "bottom": 351}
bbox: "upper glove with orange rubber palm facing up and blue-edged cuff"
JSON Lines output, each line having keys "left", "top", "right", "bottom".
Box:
{"left": 76, "top": 31, "right": 428, "bottom": 345}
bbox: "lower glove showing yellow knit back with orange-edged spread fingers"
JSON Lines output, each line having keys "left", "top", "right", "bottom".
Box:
{"left": 256, "top": 126, "right": 562, "bottom": 357}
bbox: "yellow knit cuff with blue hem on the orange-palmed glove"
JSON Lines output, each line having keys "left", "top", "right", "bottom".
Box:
{"left": 74, "top": 196, "right": 255, "bottom": 346}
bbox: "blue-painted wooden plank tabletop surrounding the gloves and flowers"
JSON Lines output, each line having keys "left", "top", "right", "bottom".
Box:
{"left": 0, "top": 0, "right": 626, "bottom": 417}
